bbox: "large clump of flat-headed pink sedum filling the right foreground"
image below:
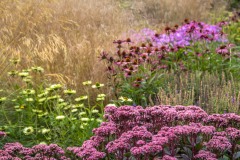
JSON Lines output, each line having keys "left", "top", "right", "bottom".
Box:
{"left": 68, "top": 105, "right": 240, "bottom": 160}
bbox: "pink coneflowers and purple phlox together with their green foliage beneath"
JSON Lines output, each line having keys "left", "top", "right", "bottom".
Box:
{"left": 100, "top": 17, "right": 239, "bottom": 106}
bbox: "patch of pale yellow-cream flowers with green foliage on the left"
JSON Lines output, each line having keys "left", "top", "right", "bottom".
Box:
{"left": 0, "top": 62, "right": 105, "bottom": 147}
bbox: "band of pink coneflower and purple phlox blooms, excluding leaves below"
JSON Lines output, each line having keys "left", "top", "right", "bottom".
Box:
{"left": 100, "top": 13, "right": 238, "bottom": 82}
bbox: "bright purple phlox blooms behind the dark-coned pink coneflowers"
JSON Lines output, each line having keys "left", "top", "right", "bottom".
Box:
{"left": 124, "top": 21, "right": 227, "bottom": 47}
